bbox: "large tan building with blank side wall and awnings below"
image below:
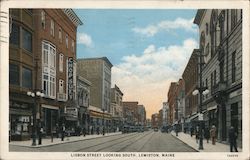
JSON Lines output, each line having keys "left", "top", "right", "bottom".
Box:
{"left": 77, "top": 57, "right": 113, "bottom": 131}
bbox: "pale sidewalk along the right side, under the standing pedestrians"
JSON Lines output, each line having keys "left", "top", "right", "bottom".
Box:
{"left": 171, "top": 131, "right": 242, "bottom": 152}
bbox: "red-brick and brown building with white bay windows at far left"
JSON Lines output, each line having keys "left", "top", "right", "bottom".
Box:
{"left": 9, "top": 9, "right": 82, "bottom": 139}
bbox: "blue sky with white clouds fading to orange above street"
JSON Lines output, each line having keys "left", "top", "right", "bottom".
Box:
{"left": 74, "top": 9, "right": 198, "bottom": 118}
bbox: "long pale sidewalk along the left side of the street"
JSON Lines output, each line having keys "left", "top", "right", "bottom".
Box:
{"left": 9, "top": 132, "right": 122, "bottom": 148}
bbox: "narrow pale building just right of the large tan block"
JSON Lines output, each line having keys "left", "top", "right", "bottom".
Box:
{"left": 110, "top": 85, "right": 123, "bottom": 130}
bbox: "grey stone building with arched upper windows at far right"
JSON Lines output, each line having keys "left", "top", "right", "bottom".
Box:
{"left": 194, "top": 9, "right": 242, "bottom": 146}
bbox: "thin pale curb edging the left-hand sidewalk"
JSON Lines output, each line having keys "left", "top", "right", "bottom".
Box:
{"left": 9, "top": 133, "right": 122, "bottom": 148}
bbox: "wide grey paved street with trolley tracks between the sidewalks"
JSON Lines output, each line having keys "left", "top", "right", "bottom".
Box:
{"left": 10, "top": 131, "right": 196, "bottom": 152}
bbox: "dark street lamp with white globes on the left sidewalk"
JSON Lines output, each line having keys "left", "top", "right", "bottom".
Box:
{"left": 27, "top": 91, "right": 44, "bottom": 146}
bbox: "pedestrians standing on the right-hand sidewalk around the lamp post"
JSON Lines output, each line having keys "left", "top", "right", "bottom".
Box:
{"left": 190, "top": 125, "right": 238, "bottom": 152}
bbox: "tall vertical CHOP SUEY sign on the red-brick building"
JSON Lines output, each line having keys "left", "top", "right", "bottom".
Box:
{"left": 68, "top": 57, "right": 74, "bottom": 100}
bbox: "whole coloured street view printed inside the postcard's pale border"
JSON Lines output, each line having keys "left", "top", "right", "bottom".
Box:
{"left": 8, "top": 8, "right": 243, "bottom": 152}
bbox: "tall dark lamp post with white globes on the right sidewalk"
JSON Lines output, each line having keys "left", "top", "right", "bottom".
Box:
{"left": 192, "top": 50, "right": 209, "bottom": 150}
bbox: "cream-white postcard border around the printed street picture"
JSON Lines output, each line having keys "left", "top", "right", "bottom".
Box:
{"left": 0, "top": 0, "right": 250, "bottom": 160}
